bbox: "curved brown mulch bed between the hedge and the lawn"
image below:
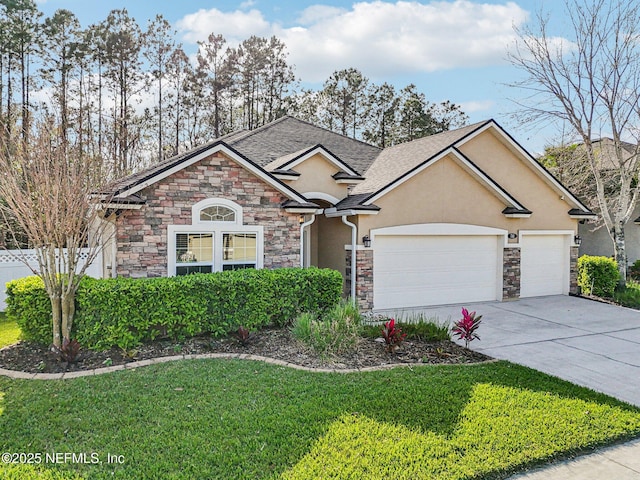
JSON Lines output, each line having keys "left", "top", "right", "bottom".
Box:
{"left": 0, "top": 329, "right": 490, "bottom": 373}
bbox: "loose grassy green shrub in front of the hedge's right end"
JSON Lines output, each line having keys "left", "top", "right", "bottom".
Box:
{"left": 291, "top": 300, "right": 361, "bottom": 355}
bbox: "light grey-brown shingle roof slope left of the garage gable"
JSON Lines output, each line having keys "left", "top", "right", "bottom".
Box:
{"left": 352, "top": 121, "right": 488, "bottom": 195}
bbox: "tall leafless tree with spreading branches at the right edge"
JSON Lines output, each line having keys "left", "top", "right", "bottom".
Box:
{"left": 510, "top": 0, "right": 640, "bottom": 284}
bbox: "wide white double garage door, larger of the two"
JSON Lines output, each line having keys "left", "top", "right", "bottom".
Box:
{"left": 373, "top": 235, "right": 502, "bottom": 309}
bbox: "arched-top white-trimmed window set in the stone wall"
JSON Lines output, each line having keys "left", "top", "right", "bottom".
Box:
{"left": 167, "top": 199, "right": 264, "bottom": 276}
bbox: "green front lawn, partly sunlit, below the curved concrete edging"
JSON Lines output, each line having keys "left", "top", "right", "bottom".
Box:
{"left": 0, "top": 360, "right": 640, "bottom": 480}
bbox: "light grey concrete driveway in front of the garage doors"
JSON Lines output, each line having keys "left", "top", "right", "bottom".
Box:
{"left": 385, "top": 295, "right": 640, "bottom": 406}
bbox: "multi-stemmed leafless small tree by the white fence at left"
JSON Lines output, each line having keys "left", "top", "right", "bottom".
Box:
{"left": 0, "top": 124, "right": 107, "bottom": 348}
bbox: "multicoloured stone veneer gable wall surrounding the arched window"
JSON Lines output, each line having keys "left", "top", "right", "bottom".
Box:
{"left": 116, "top": 150, "right": 300, "bottom": 277}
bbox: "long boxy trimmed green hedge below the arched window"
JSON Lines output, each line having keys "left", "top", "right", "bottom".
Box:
{"left": 7, "top": 268, "right": 342, "bottom": 350}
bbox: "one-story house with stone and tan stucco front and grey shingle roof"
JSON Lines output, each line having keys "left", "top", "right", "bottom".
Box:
{"left": 95, "top": 117, "right": 593, "bottom": 309}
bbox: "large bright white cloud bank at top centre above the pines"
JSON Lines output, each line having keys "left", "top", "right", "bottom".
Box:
{"left": 178, "top": 0, "right": 527, "bottom": 82}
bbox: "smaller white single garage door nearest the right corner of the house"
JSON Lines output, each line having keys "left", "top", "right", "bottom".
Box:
{"left": 520, "top": 235, "right": 569, "bottom": 297}
